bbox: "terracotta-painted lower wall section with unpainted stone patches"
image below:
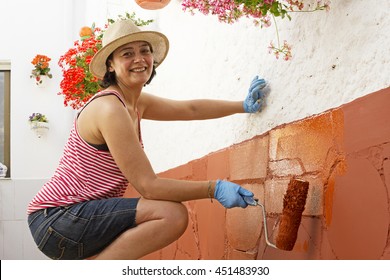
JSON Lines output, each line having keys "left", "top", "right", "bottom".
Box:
{"left": 125, "top": 88, "right": 390, "bottom": 260}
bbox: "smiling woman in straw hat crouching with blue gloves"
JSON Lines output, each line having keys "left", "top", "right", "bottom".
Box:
{"left": 28, "top": 20, "right": 265, "bottom": 259}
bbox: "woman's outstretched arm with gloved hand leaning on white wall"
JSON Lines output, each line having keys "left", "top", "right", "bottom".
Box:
{"left": 140, "top": 76, "right": 266, "bottom": 121}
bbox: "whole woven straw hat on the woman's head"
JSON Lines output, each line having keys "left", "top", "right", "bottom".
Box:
{"left": 89, "top": 20, "right": 169, "bottom": 79}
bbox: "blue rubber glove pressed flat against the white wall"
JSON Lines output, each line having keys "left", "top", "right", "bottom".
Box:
{"left": 243, "top": 76, "right": 267, "bottom": 113}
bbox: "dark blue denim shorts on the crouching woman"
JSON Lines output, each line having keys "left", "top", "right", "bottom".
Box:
{"left": 28, "top": 198, "right": 139, "bottom": 260}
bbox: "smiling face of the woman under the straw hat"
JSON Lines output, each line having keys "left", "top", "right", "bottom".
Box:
{"left": 109, "top": 41, "right": 153, "bottom": 86}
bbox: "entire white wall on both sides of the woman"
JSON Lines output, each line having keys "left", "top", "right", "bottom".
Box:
{"left": 0, "top": 0, "right": 390, "bottom": 259}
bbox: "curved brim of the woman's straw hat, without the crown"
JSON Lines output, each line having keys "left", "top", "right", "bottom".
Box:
{"left": 89, "top": 31, "right": 169, "bottom": 79}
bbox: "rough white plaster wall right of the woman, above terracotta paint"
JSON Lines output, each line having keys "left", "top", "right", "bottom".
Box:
{"left": 138, "top": 0, "right": 390, "bottom": 171}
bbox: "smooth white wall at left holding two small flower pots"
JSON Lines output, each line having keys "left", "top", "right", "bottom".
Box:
{"left": 0, "top": 0, "right": 77, "bottom": 179}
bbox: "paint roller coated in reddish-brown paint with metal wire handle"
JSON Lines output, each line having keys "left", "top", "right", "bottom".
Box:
{"left": 244, "top": 178, "right": 309, "bottom": 251}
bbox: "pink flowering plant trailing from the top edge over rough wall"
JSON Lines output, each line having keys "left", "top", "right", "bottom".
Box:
{"left": 182, "top": 0, "right": 330, "bottom": 60}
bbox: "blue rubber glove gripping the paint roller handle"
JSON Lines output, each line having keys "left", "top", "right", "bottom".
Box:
{"left": 214, "top": 180, "right": 253, "bottom": 208}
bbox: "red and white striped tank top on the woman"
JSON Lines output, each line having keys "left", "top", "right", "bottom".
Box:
{"left": 27, "top": 91, "right": 142, "bottom": 214}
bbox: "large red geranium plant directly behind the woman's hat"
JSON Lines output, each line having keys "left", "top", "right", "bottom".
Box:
{"left": 58, "top": 13, "right": 153, "bottom": 109}
